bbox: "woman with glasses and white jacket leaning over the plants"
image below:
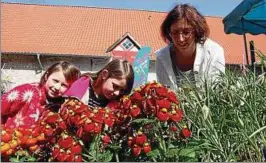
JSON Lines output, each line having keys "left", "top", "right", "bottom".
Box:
{"left": 156, "top": 4, "right": 225, "bottom": 89}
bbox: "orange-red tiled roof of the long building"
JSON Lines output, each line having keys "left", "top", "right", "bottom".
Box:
{"left": 1, "top": 3, "right": 266, "bottom": 64}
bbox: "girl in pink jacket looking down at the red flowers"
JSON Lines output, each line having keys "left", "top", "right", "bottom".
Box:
{"left": 65, "top": 59, "right": 134, "bottom": 107}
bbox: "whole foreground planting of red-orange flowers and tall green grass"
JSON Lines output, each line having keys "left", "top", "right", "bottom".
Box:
{"left": 1, "top": 56, "right": 266, "bottom": 162}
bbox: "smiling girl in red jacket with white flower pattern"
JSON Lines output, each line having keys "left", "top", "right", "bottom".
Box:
{"left": 1, "top": 61, "right": 80, "bottom": 128}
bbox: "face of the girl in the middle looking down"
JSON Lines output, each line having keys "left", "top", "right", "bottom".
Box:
{"left": 101, "top": 77, "right": 127, "bottom": 100}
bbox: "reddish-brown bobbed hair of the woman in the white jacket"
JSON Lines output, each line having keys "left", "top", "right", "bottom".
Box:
{"left": 161, "top": 4, "right": 210, "bottom": 44}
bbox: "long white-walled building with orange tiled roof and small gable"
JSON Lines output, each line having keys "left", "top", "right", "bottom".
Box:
{"left": 1, "top": 3, "right": 266, "bottom": 89}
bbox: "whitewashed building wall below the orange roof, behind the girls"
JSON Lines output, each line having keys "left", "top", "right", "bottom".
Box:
{"left": 1, "top": 54, "right": 156, "bottom": 89}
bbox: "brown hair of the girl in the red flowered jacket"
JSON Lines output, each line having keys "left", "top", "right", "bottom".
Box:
{"left": 39, "top": 61, "right": 80, "bottom": 87}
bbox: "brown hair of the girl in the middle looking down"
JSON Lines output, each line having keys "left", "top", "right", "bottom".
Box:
{"left": 82, "top": 59, "right": 134, "bottom": 95}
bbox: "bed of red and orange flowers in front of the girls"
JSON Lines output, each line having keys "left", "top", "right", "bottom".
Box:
{"left": 1, "top": 83, "right": 191, "bottom": 162}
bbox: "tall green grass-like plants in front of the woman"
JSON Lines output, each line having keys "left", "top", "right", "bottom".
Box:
{"left": 177, "top": 64, "right": 266, "bottom": 162}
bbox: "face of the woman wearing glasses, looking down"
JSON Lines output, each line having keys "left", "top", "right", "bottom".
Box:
{"left": 170, "top": 20, "right": 195, "bottom": 51}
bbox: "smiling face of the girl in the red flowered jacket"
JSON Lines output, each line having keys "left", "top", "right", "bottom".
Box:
{"left": 44, "top": 71, "right": 70, "bottom": 98}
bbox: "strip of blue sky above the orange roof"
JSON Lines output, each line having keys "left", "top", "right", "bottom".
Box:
{"left": 2, "top": 0, "right": 242, "bottom": 17}
